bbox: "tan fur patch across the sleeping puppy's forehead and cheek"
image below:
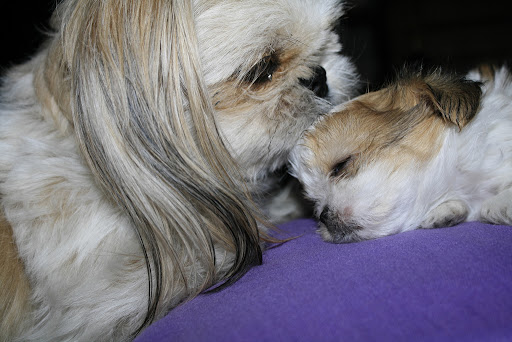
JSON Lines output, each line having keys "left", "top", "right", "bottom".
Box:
{"left": 305, "top": 83, "right": 446, "bottom": 177}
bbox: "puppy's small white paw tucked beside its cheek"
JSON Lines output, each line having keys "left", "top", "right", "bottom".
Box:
{"left": 420, "top": 200, "right": 469, "bottom": 228}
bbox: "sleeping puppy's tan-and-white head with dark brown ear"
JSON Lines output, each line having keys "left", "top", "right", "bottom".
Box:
{"left": 291, "top": 72, "right": 481, "bottom": 243}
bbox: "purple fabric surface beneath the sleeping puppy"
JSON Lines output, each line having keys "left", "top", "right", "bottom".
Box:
{"left": 136, "top": 220, "right": 512, "bottom": 342}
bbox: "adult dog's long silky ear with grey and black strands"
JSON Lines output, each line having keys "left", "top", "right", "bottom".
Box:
{"left": 54, "top": 0, "right": 261, "bottom": 330}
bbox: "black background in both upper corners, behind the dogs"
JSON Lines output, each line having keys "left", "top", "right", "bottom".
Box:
{"left": 0, "top": 0, "right": 512, "bottom": 88}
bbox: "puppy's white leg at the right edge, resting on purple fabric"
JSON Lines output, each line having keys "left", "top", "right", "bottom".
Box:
{"left": 480, "top": 188, "right": 512, "bottom": 225}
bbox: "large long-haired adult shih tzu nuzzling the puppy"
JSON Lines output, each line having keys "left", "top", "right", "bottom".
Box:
{"left": 0, "top": 0, "right": 356, "bottom": 341}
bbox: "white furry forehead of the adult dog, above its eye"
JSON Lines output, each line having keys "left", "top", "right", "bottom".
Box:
{"left": 196, "top": 0, "right": 342, "bottom": 78}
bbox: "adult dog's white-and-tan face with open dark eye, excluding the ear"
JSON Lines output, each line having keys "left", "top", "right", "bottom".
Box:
{"left": 196, "top": 0, "right": 356, "bottom": 179}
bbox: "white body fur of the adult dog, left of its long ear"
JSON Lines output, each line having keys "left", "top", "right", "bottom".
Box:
{"left": 0, "top": 56, "right": 147, "bottom": 341}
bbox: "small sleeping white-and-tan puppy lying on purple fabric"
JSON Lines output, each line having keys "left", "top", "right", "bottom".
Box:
{"left": 291, "top": 67, "right": 512, "bottom": 243}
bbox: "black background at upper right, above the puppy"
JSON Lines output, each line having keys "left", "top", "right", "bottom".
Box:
{"left": 341, "top": 0, "right": 512, "bottom": 88}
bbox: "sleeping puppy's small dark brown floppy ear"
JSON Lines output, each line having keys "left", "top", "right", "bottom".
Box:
{"left": 422, "top": 73, "right": 482, "bottom": 129}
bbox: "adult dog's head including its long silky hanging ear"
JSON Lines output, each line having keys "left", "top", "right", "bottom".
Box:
{"left": 36, "top": 0, "right": 355, "bottom": 332}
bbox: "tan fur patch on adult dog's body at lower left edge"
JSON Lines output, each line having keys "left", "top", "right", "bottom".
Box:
{"left": 0, "top": 211, "right": 30, "bottom": 341}
